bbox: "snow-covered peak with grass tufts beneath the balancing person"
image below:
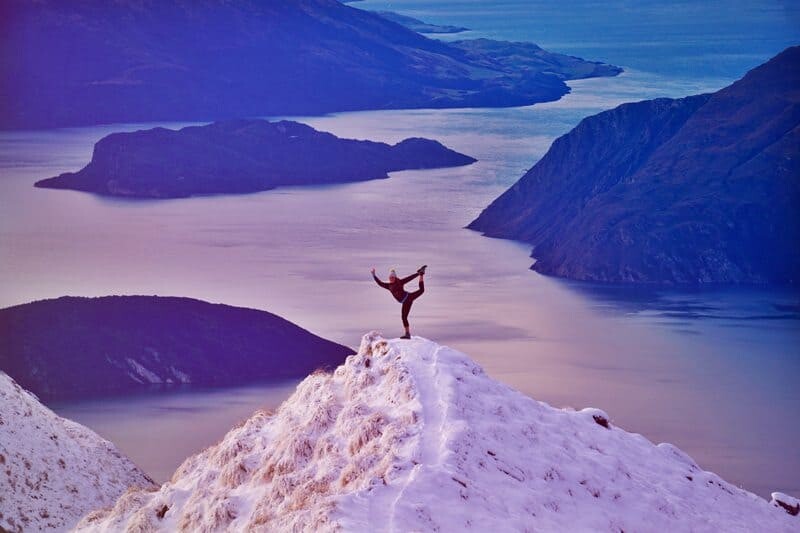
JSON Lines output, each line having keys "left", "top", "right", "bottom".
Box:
{"left": 73, "top": 334, "right": 800, "bottom": 532}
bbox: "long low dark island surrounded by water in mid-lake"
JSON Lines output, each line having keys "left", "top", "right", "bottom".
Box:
{"left": 36, "top": 120, "right": 475, "bottom": 198}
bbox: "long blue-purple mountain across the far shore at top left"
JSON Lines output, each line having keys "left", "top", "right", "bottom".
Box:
{"left": 0, "top": 0, "right": 621, "bottom": 129}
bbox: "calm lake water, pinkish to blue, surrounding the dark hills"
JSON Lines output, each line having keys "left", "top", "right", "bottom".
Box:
{"left": 0, "top": 0, "right": 800, "bottom": 495}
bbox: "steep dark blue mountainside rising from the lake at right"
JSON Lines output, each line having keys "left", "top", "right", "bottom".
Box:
{"left": 469, "top": 47, "right": 800, "bottom": 284}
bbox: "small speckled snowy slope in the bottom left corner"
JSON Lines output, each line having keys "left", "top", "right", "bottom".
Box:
{"left": 0, "top": 372, "right": 153, "bottom": 531}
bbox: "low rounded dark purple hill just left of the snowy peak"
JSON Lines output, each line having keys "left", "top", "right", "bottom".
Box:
{"left": 0, "top": 296, "right": 352, "bottom": 398}
